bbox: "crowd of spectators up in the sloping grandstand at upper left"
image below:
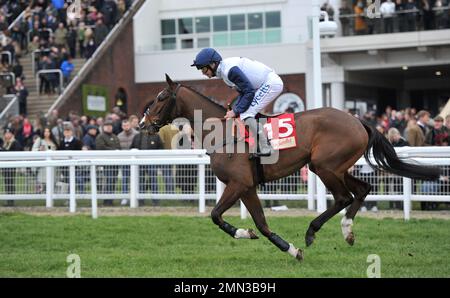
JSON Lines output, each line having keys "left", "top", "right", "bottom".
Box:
{"left": 0, "top": 0, "right": 132, "bottom": 100}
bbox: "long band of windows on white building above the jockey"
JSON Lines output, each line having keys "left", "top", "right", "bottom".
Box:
{"left": 161, "top": 11, "right": 282, "bottom": 50}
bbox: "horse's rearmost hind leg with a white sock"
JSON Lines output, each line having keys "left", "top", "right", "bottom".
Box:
{"left": 341, "top": 173, "right": 372, "bottom": 245}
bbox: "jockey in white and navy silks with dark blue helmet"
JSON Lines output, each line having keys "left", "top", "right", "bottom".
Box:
{"left": 191, "top": 48, "right": 283, "bottom": 156}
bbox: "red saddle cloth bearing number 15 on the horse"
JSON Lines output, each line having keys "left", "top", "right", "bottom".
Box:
{"left": 234, "top": 113, "right": 297, "bottom": 150}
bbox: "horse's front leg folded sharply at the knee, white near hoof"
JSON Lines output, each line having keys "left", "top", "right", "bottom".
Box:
{"left": 211, "top": 182, "right": 258, "bottom": 239}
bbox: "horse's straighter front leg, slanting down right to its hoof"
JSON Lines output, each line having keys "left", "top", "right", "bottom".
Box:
{"left": 242, "top": 187, "right": 303, "bottom": 261}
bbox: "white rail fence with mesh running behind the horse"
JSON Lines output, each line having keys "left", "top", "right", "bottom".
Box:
{"left": 0, "top": 147, "right": 450, "bottom": 219}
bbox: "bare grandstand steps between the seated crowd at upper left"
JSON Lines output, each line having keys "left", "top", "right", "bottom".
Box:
{"left": 20, "top": 55, "right": 86, "bottom": 119}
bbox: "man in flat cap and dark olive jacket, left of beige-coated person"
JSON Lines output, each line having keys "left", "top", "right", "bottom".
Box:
{"left": 95, "top": 120, "right": 120, "bottom": 206}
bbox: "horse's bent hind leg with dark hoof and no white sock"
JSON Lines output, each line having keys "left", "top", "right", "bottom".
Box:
{"left": 305, "top": 166, "right": 353, "bottom": 246}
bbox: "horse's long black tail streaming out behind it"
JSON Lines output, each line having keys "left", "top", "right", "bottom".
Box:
{"left": 361, "top": 120, "right": 441, "bottom": 180}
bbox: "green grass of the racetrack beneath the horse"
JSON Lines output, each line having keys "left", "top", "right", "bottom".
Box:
{"left": 0, "top": 213, "right": 450, "bottom": 277}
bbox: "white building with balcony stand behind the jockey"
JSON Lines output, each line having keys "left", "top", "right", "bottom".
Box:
{"left": 133, "top": 0, "right": 450, "bottom": 113}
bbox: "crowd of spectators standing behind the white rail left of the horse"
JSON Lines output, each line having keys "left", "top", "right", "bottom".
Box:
{"left": 0, "top": 107, "right": 196, "bottom": 206}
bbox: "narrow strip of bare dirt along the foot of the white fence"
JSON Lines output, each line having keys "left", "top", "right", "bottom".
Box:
{"left": 0, "top": 207, "right": 450, "bottom": 220}
